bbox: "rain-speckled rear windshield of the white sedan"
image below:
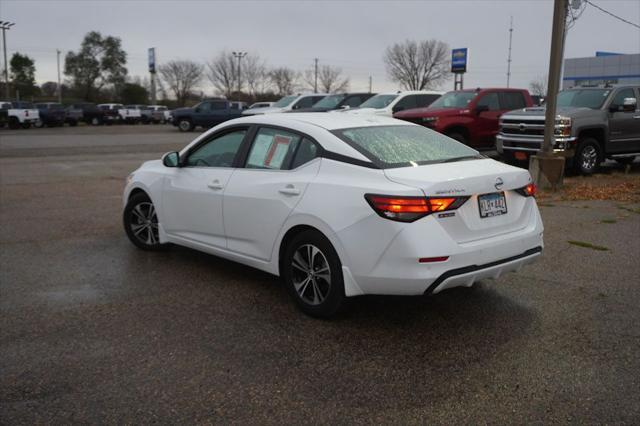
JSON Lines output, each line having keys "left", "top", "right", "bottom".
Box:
{"left": 333, "top": 126, "right": 484, "bottom": 169}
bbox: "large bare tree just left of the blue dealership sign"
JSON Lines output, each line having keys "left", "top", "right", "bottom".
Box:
{"left": 384, "top": 40, "right": 450, "bottom": 90}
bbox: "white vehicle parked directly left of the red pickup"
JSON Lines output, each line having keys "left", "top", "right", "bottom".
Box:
{"left": 347, "top": 90, "right": 442, "bottom": 117}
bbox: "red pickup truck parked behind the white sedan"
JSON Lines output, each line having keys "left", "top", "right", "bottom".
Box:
{"left": 393, "top": 88, "right": 533, "bottom": 149}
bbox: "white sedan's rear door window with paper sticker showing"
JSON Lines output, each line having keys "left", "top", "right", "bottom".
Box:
{"left": 246, "top": 127, "right": 300, "bottom": 170}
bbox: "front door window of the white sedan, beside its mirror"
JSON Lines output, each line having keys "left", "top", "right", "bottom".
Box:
{"left": 186, "top": 129, "right": 247, "bottom": 167}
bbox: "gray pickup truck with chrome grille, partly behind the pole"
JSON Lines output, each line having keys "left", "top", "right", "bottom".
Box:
{"left": 496, "top": 86, "right": 640, "bottom": 174}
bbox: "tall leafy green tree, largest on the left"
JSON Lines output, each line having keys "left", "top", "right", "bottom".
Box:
{"left": 64, "top": 31, "right": 127, "bottom": 101}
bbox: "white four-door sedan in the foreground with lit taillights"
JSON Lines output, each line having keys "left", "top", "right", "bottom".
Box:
{"left": 123, "top": 113, "right": 543, "bottom": 317}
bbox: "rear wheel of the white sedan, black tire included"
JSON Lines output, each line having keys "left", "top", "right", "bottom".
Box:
{"left": 280, "top": 230, "right": 346, "bottom": 318}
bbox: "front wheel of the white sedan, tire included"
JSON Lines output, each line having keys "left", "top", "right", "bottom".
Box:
{"left": 122, "top": 193, "right": 166, "bottom": 250}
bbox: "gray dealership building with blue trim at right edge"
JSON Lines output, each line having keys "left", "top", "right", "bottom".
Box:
{"left": 562, "top": 52, "right": 640, "bottom": 89}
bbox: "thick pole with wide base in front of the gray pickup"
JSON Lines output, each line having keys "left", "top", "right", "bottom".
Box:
{"left": 529, "top": 0, "right": 568, "bottom": 189}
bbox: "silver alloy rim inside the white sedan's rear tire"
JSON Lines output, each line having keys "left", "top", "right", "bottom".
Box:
{"left": 291, "top": 244, "right": 331, "bottom": 305}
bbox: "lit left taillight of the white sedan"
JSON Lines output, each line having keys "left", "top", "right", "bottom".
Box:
{"left": 364, "top": 194, "right": 469, "bottom": 222}
